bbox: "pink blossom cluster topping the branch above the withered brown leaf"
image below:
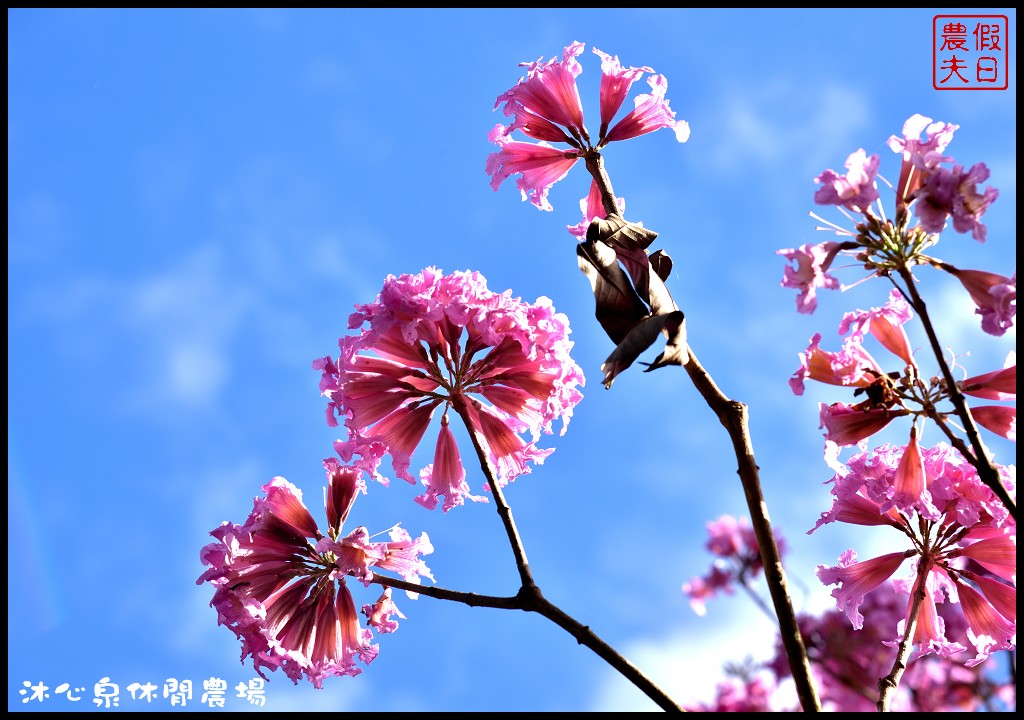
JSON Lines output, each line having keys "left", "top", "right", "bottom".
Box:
{"left": 485, "top": 42, "right": 690, "bottom": 210}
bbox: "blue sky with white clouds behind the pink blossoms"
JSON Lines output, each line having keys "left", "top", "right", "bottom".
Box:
{"left": 7, "top": 9, "right": 1017, "bottom": 711}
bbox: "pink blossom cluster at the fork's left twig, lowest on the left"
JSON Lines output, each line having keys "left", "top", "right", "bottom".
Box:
{"left": 196, "top": 459, "right": 433, "bottom": 688}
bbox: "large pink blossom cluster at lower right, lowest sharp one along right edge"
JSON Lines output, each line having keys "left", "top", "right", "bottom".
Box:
{"left": 811, "top": 436, "right": 1017, "bottom": 666}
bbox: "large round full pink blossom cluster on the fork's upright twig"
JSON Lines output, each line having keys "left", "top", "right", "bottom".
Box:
{"left": 313, "top": 267, "right": 584, "bottom": 511}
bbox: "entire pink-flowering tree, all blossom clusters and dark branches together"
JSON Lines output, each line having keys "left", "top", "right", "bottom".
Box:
{"left": 197, "top": 42, "right": 1017, "bottom": 712}
